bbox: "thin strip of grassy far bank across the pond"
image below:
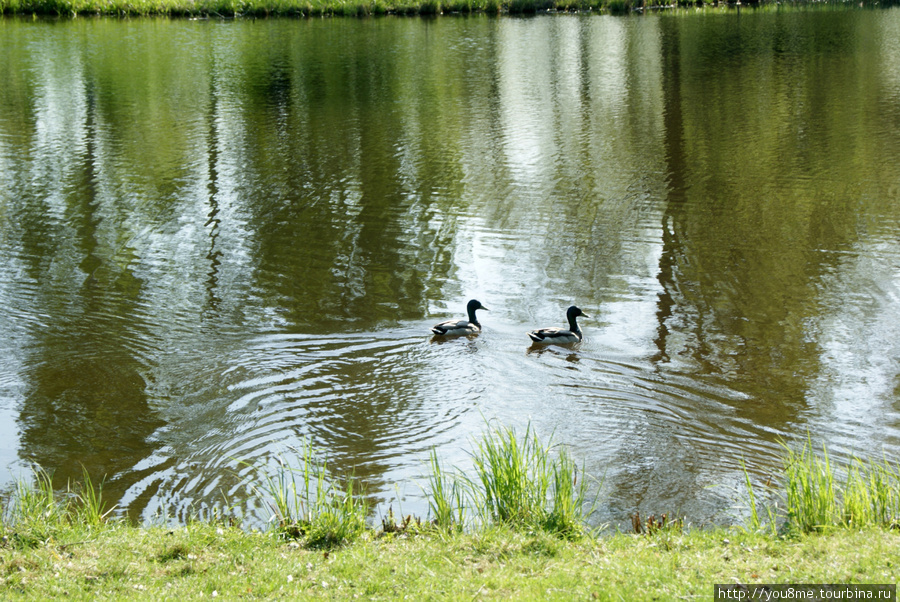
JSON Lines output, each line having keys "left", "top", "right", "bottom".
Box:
{"left": 0, "top": 0, "right": 898, "bottom": 18}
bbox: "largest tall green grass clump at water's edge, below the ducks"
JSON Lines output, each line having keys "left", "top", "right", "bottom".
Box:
{"left": 428, "top": 425, "right": 597, "bottom": 539}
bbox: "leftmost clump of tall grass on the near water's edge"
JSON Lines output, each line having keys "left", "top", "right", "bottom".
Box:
{"left": 0, "top": 467, "right": 115, "bottom": 547}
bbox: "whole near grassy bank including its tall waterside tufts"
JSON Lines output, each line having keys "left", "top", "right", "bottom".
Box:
{"left": 0, "top": 429, "right": 900, "bottom": 600}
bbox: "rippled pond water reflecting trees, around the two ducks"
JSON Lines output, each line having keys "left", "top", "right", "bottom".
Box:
{"left": 0, "top": 8, "right": 900, "bottom": 524}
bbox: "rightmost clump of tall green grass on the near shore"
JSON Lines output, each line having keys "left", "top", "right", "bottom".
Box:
{"left": 744, "top": 437, "right": 900, "bottom": 533}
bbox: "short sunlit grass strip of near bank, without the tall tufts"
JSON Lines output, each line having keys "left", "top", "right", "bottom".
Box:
{"left": 0, "top": 524, "right": 900, "bottom": 600}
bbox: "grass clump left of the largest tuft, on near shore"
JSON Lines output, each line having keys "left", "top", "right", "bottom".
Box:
{"left": 245, "top": 442, "right": 369, "bottom": 547}
